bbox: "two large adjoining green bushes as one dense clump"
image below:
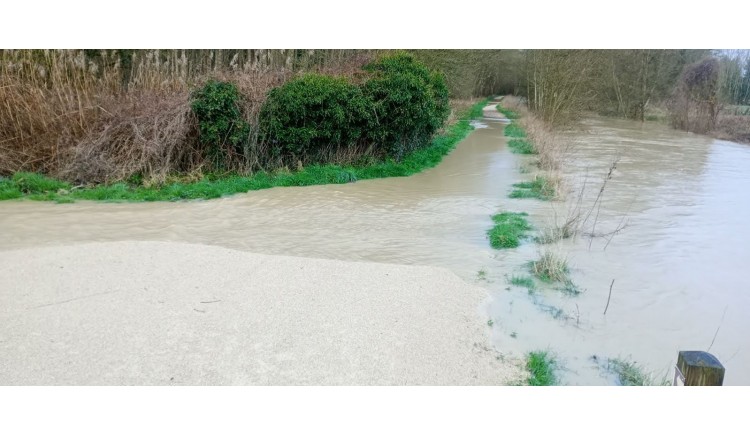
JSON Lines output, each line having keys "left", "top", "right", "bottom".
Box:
{"left": 259, "top": 52, "right": 450, "bottom": 163}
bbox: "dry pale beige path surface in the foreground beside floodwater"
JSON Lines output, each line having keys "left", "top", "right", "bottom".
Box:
{"left": 0, "top": 242, "right": 524, "bottom": 385}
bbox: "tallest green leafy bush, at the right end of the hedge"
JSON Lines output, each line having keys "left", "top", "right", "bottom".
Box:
{"left": 364, "top": 53, "right": 450, "bottom": 160}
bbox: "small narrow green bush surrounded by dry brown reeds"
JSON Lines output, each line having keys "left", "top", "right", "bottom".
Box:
{"left": 191, "top": 80, "right": 250, "bottom": 167}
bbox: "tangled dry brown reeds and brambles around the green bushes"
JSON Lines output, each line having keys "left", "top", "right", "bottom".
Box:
{"left": 0, "top": 50, "right": 370, "bottom": 183}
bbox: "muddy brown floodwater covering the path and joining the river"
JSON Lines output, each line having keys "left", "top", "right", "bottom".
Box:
{"left": 0, "top": 104, "right": 750, "bottom": 385}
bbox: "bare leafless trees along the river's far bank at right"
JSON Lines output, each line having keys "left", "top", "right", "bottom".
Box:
{"left": 517, "top": 49, "right": 750, "bottom": 142}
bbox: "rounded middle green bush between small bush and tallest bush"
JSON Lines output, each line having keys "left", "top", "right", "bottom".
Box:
{"left": 260, "top": 74, "right": 372, "bottom": 160}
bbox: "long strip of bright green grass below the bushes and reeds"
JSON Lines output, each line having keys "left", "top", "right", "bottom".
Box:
{"left": 0, "top": 99, "right": 489, "bottom": 203}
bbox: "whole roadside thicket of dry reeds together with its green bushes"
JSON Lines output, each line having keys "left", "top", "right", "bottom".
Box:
{"left": 0, "top": 50, "right": 450, "bottom": 185}
